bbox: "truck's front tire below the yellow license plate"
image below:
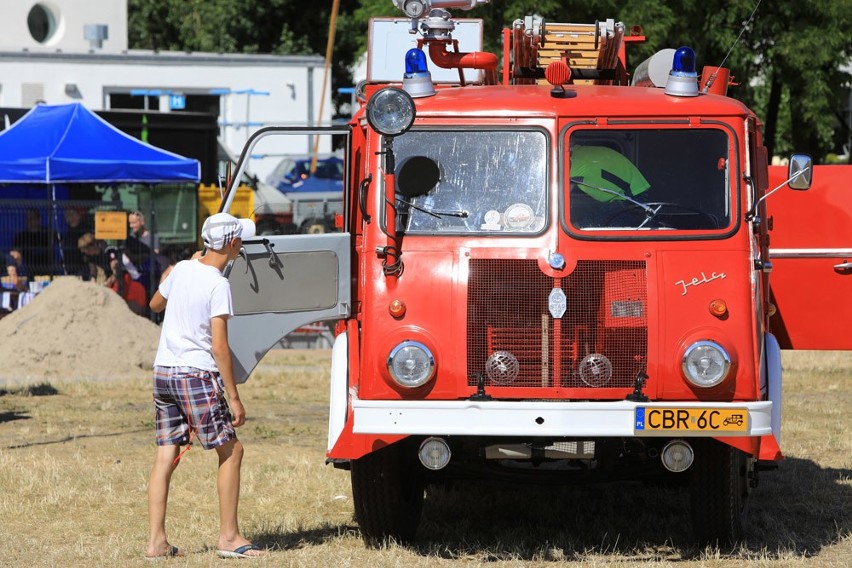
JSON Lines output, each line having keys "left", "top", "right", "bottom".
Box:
{"left": 689, "top": 440, "right": 754, "bottom": 547}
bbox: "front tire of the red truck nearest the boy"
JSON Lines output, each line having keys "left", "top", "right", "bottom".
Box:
{"left": 351, "top": 443, "right": 424, "bottom": 548}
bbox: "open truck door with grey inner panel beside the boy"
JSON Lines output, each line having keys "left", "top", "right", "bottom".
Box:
{"left": 221, "top": 127, "right": 351, "bottom": 383}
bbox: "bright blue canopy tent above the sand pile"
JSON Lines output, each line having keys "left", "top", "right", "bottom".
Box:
{"left": 0, "top": 103, "right": 201, "bottom": 298}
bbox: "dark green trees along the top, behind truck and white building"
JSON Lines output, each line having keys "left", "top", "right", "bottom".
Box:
{"left": 128, "top": 0, "right": 852, "bottom": 162}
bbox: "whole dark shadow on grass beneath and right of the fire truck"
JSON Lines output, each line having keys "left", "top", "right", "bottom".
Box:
{"left": 400, "top": 457, "right": 852, "bottom": 561}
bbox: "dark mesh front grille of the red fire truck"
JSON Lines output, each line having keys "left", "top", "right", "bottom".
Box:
{"left": 467, "top": 259, "right": 648, "bottom": 388}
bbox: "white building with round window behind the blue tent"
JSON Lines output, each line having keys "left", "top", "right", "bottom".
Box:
{"left": 0, "top": 0, "right": 332, "bottom": 179}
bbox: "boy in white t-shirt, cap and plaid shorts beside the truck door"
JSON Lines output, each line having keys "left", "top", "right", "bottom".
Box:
{"left": 146, "top": 213, "right": 264, "bottom": 558}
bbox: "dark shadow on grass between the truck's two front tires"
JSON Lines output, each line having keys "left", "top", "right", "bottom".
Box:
{"left": 413, "top": 482, "right": 695, "bottom": 562}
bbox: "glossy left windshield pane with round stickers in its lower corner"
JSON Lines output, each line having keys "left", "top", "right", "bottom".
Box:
{"left": 394, "top": 130, "right": 547, "bottom": 235}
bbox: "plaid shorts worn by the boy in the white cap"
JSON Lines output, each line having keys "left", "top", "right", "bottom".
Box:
{"left": 154, "top": 367, "right": 237, "bottom": 450}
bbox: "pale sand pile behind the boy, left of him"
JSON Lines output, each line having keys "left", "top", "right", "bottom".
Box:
{"left": 0, "top": 277, "right": 160, "bottom": 382}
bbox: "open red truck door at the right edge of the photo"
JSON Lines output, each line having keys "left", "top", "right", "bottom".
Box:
{"left": 766, "top": 166, "right": 852, "bottom": 350}
